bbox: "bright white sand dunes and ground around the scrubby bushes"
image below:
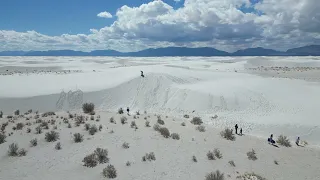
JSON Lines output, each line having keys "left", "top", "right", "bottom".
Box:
{"left": 0, "top": 57, "right": 320, "bottom": 180}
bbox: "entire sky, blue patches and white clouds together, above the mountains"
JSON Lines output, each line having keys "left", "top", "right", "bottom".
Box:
{"left": 0, "top": 0, "right": 320, "bottom": 52}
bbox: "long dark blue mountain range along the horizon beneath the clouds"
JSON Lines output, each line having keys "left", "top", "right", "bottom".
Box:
{"left": 0, "top": 45, "right": 320, "bottom": 57}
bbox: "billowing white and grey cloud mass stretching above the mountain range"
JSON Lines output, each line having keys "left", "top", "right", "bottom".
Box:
{"left": 0, "top": 0, "right": 320, "bottom": 52}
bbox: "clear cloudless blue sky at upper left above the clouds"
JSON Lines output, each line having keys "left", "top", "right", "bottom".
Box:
{"left": 0, "top": 0, "right": 183, "bottom": 35}
